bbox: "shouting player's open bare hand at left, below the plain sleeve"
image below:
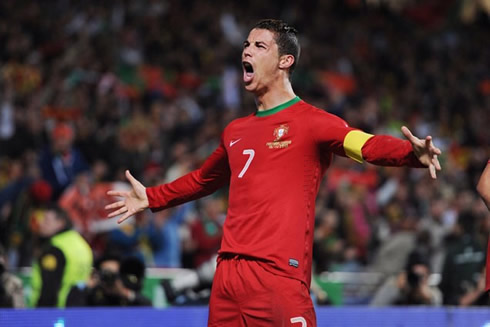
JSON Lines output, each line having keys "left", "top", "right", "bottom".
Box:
{"left": 105, "top": 170, "right": 149, "bottom": 224}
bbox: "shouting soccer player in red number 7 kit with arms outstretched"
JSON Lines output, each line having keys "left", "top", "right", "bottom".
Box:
{"left": 107, "top": 20, "right": 441, "bottom": 327}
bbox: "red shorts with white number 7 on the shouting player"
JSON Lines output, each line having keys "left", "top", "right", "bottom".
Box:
{"left": 208, "top": 255, "right": 316, "bottom": 327}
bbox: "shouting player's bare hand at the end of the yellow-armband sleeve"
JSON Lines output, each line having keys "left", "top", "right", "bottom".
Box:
{"left": 402, "top": 126, "right": 442, "bottom": 179}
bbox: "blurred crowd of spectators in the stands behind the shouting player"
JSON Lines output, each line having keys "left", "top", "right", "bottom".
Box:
{"left": 0, "top": 0, "right": 490, "bottom": 305}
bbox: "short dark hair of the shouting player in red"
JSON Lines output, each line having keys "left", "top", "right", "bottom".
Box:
{"left": 253, "top": 19, "right": 301, "bottom": 75}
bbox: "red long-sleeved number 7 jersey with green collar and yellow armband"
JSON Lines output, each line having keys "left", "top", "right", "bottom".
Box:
{"left": 146, "top": 97, "right": 422, "bottom": 287}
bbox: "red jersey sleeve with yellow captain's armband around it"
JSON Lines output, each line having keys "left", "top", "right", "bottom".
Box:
{"left": 311, "top": 112, "right": 424, "bottom": 167}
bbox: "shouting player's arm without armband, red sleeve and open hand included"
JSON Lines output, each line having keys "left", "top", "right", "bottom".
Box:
{"left": 105, "top": 143, "right": 230, "bottom": 223}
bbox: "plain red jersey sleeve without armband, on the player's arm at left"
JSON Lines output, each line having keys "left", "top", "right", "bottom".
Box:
{"left": 146, "top": 138, "right": 230, "bottom": 211}
